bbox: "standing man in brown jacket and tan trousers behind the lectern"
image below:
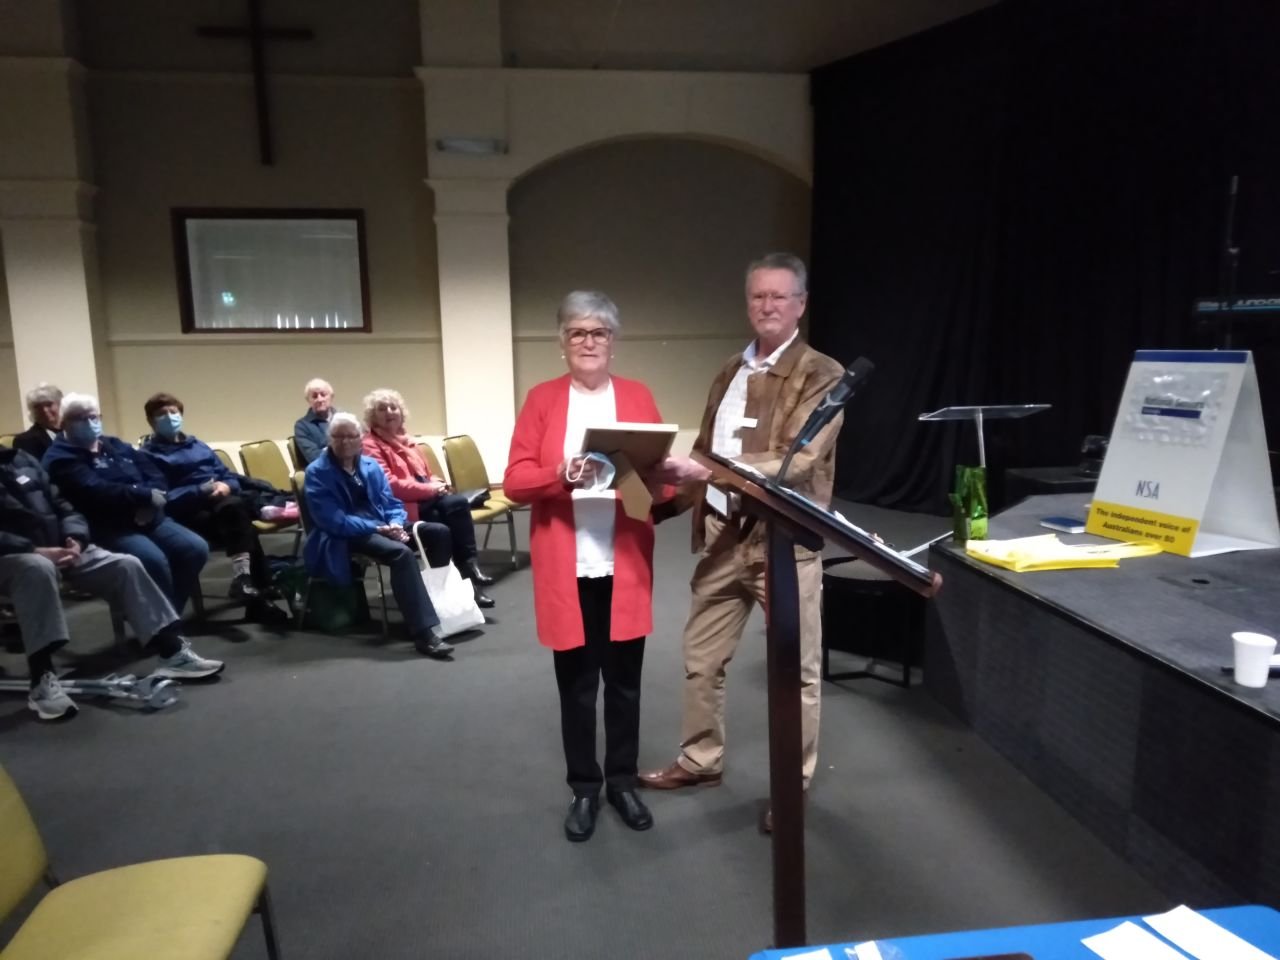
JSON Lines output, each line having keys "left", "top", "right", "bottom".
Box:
{"left": 640, "top": 253, "right": 844, "bottom": 828}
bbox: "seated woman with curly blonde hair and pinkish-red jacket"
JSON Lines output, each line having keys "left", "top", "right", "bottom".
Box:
{"left": 364, "top": 389, "right": 493, "bottom": 608}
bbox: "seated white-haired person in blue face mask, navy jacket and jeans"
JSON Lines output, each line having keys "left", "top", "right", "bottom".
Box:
{"left": 44, "top": 393, "right": 209, "bottom": 614}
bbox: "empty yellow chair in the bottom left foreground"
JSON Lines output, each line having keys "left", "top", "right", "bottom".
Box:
{"left": 0, "top": 767, "right": 280, "bottom": 960}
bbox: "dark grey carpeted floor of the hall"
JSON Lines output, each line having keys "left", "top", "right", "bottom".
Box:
{"left": 0, "top": 515, "right": 1170, "bottom": 960}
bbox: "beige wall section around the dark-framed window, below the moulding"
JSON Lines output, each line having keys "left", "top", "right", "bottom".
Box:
{"left": 88, "top": 72, "right": 444, "bottom": 439}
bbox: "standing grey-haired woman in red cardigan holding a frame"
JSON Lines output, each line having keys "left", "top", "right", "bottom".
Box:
{"left": 502, "top": 291, "right": 662, "bottom": 841}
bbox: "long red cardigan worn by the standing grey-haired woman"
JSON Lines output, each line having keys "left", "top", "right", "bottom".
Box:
{"left": 504, "top": 375, "right": 669, "bottom": 650}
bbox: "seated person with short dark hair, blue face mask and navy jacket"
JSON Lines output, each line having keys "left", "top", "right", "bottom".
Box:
{"left": 142, "top": 393, "right": 288, "bottom": 623}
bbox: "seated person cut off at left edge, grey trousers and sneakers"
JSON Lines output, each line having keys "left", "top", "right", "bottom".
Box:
{"left": 0, "top": 448, "right": 223, "bottom": 721}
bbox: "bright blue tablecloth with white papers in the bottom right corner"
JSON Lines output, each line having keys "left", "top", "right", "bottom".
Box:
{"left": 751, "top": 906, "right": 1280, "bottom": 960}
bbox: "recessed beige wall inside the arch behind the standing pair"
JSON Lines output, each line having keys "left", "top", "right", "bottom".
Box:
{"left": 509, "top": 140, "right": 809, "bottom": 428}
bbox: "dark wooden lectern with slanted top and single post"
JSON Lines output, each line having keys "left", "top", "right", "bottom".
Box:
{"left": 692, "top": 453, "right": 942, "bottom": 947}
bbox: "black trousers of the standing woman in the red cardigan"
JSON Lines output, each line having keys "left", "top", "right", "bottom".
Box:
{"left": 552, "top": 577, "right": 644, "bottom": 796}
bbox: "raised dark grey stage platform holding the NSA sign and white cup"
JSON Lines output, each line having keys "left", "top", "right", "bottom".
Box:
{"left": 924, "top": 494, "right": 1280, "bottom": 906}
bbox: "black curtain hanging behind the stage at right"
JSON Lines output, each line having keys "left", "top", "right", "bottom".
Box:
{"left": 810, "top": 0, "right": 1280, "bottom": 511}
